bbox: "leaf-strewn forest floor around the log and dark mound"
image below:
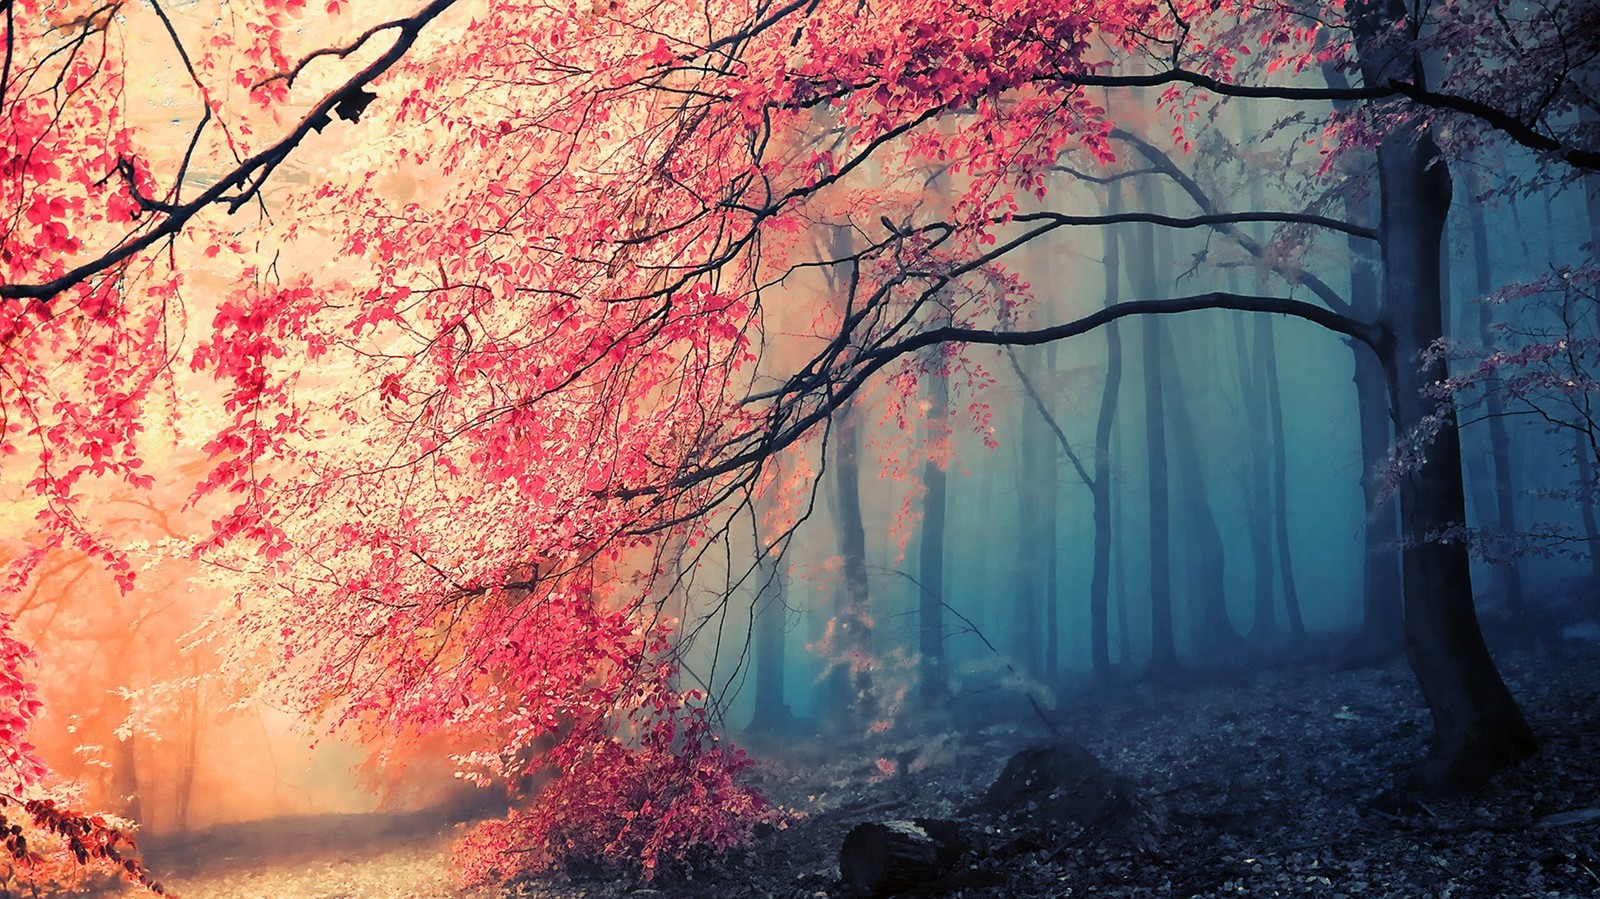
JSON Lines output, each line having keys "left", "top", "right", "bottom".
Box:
{"left": 112, "top": 623, "right": 1600, "bottom": 899}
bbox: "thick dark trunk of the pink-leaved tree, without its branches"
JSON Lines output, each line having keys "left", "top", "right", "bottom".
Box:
{"left": 1355, "top": 0, "right": 1534, "bottom": 792}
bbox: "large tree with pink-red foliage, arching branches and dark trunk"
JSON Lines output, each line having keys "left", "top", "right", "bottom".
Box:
{"left": 0, "top": 0, "right": 1600, "bottom": 870}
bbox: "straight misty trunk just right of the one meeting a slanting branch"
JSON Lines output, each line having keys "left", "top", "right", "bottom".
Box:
{"left": 1126, "top": 179, "right": 1179, "bottom": 677}
